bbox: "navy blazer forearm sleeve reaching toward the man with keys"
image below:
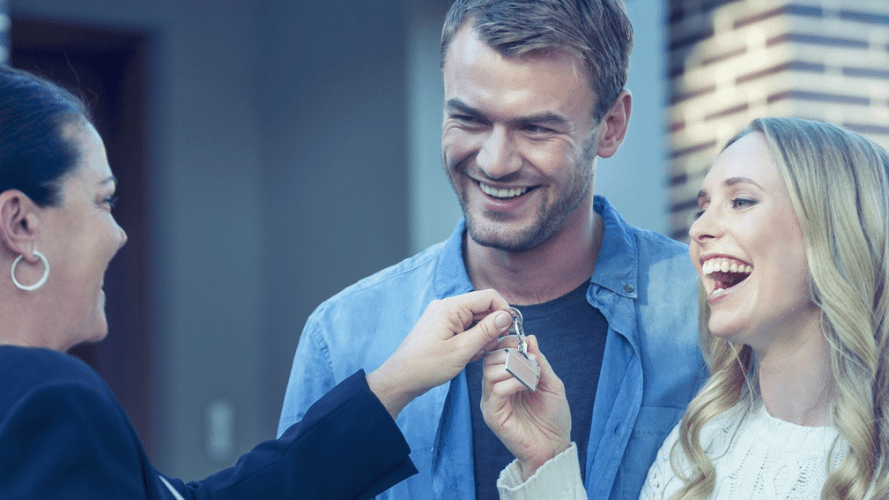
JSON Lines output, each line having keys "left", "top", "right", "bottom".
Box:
{"left": 170, "top": 371, "right": 417, "bottom": 500}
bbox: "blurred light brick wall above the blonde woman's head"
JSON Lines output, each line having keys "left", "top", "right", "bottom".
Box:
{"left": 667, "top": 0, "right": 889, "bottom": 240}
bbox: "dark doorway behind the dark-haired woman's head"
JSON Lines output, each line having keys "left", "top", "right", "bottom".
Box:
{"left": 10, "top": 17, "right": 154, "bottom": 457}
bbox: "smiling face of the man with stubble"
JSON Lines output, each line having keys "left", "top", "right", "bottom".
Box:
{"left": 441, "top": 24, "right": 598, "bottom": 252}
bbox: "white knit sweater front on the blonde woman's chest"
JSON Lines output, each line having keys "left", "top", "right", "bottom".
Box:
{"left": 640, "top": 405, "right": 847, "bottom": 500}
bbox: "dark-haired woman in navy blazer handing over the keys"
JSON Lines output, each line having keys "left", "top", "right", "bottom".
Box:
{"left": 0, "top": 66, "right": 510, "bottom": 499}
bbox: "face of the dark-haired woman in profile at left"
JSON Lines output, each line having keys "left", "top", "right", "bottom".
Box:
{"left": 36, "top": 123, "right": 127, "bottom": 351}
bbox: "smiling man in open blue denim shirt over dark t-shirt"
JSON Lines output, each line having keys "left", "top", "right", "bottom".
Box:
{"left": 281, "top": 0, "right": 704, "bottom": 500}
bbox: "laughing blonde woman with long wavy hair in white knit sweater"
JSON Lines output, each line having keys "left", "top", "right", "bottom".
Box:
{"left": 487, "top": 118, "right": 889, "bottom": 500}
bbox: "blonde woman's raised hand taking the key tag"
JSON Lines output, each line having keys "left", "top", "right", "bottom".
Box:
{"left": 481, "top": 335, "right": 571, "bottom": 480}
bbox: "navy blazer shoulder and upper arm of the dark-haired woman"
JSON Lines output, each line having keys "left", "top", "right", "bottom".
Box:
{"left": 0, "top": 346, "right": 163, "bottom": 498}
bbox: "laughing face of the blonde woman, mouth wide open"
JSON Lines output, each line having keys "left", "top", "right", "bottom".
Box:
{"left": 689, "top": 132, "right": 819, "bottom": 354}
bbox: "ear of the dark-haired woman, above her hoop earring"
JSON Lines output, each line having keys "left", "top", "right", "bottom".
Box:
{"left": 0, "top": 189, "right": 40, "bottom": 262}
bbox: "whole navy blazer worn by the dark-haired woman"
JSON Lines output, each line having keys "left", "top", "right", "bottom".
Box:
{"left": 0, "top": 346, "right": 417, "bottom": 500}
